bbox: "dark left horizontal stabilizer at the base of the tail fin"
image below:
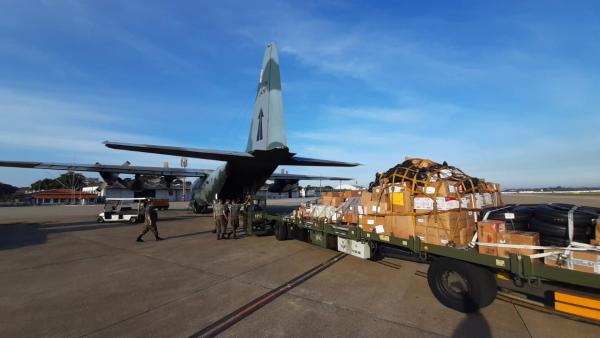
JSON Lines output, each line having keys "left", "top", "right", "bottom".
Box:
{"left": 104, "top": 141, "right": 254, "bottom": 161}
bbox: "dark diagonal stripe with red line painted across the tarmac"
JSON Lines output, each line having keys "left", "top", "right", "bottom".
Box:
{"left": 190, "top": 253, "right": 346, "bottom": 337}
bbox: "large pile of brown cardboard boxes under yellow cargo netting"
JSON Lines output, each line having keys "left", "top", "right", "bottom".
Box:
{"left": 298, "top": 159, "right": 501, "bottom": 246}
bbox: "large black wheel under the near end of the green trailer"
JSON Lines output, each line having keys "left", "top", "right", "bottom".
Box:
{"left": 427, "top": 258, "right": 498, "bottom": 313}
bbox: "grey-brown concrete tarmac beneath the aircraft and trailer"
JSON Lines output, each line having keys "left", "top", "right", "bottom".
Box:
{"left": 0, "top": 200, "right": 600, "bottom": 338}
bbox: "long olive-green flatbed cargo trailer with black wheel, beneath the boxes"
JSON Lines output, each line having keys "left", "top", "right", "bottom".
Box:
{"left": 264, "top": 215, "right": 600, "bottom": 325}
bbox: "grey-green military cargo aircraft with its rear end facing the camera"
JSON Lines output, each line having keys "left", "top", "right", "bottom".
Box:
{"left": 0, "top": 43, "right": 359, "bottom": 213}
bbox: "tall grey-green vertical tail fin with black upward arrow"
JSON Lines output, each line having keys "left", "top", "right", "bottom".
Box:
{"left": 246, "top": 42, "right": 287, "bottom": 152}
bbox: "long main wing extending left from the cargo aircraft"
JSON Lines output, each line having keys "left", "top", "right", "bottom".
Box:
{"left": 0, "top": 161, "right": 212, "bottom": 177}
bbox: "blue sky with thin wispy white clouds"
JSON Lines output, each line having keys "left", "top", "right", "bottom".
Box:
{"left": 0, "top": 0, "right": 600, "bottom": 187}
